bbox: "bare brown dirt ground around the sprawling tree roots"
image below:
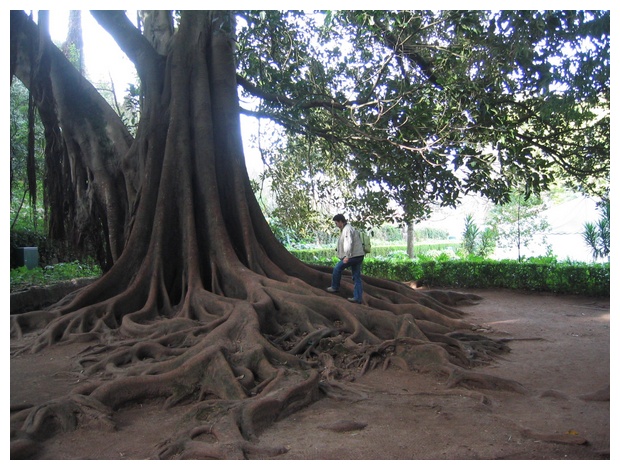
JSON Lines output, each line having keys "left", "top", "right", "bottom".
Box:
{"left": 10, "top": 290, "right": 610, "bottom": 460}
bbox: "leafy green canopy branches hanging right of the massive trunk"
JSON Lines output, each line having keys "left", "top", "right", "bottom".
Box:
{"left": 238, "top": 10, "right": 610, "bottom": 226}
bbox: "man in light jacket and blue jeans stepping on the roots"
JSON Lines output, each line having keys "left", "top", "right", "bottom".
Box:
{"left": 327, "top": 214, "right": 366, "bottom": 304}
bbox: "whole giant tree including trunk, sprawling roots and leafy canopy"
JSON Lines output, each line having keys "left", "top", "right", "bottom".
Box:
{"left": 11, "top": 11, "right": 607, "bottom": 458}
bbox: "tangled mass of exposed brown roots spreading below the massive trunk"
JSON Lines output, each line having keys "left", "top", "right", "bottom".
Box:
{"left": 12, "top": 275, "right": 524, "bottom": 459}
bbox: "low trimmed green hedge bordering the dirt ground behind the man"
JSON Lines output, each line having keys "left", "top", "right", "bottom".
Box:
{"left": 294, "top": 252, "right": 610, "bottom": 297}
